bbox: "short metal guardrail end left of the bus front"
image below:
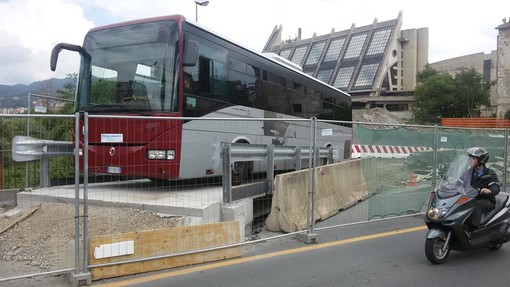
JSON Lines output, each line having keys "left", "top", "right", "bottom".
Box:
{"left": 12, "top": 136, "right": 74, "bottom": 188}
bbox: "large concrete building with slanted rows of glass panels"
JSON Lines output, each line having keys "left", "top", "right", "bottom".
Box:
{"left": 263, "top": 12, "right": 429, "bottom": 118}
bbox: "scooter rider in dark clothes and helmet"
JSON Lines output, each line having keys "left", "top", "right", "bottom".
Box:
{"left": 467, "top": 147, "right": 500, "bottom": 231}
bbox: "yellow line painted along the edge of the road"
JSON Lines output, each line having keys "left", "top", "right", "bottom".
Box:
{"left": 98, "top": 225, "right": 427, "bottom": 287}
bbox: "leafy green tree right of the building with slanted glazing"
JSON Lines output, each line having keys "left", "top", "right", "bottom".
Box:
{"left": 413, "top": 65, "right": 494, "bottom": 123}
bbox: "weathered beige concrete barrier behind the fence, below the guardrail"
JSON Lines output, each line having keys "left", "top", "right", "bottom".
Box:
{"left": 266, "top": 159, "right": 368, "bottom": 232}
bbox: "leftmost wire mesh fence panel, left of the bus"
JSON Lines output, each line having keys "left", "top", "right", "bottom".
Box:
{"left": 0, "top": 115, "right": 76, "bottom": 280}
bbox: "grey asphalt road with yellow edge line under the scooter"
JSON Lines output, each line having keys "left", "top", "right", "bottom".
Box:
{"left": 90, "top": 217, "right": 510, "bottom": 287}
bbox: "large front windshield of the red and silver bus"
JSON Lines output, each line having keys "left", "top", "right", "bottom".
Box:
{"left": 76, "top": 21, "right": 179, "bottom": 114}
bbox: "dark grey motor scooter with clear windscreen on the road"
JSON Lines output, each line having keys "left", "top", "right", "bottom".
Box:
{"left": 425, "top": 154, "right": 510, "bottom": 264}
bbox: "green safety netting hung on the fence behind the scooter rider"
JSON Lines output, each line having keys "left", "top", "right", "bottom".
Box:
{"left": 353, "top": 124, "right": 505, "bottom": 220}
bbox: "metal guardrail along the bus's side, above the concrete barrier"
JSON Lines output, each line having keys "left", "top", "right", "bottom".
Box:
{"left": 221, "top": 143, "right": 332, "bottom": 203}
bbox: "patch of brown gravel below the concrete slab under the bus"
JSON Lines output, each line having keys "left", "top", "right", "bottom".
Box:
{"left": 0, "top": 203, "right": 184, "bottom": 277}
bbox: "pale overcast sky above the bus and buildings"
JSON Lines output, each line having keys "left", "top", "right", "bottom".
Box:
{"left": 0, "top": 0, "right": 510, "bottom": 85}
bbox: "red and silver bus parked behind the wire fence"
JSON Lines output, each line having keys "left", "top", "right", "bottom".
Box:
{"left": 51, "top": 15, "right": 352, "bottom": 180}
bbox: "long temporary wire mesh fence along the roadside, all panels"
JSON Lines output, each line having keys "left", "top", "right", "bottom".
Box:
{"left": 0, "top": 114, "right": 508, "bottom": 282}
